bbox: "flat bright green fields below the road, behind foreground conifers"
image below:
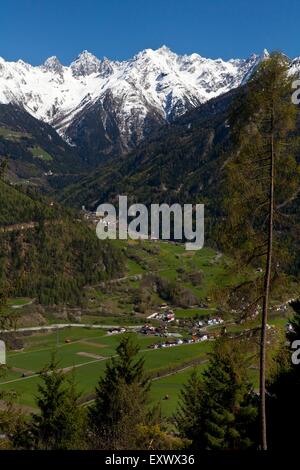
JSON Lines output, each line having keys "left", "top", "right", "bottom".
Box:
{"left": 0, "top": 328, "right": 211, "bottom": 413}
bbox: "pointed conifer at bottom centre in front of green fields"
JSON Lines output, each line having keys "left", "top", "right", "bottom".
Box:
{"left": 89, "top": 336, "right": 149, "bottom": 449}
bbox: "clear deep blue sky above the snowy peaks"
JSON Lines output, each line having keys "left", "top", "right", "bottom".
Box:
{"left": 0, "top": 0, "right": 300, "bottom": 64}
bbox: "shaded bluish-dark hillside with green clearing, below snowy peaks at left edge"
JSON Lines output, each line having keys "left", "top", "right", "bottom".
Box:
{"left": 0, "top": 104, "right": 86, "bottom": 188}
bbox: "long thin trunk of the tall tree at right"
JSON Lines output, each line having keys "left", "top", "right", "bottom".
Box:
{"left": 259, "top": 104, "right": 275, "bottom": 450}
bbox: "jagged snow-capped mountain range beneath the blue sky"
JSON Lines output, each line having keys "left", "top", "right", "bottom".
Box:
{"left": 0, "top": 46, "right": 274, "bottom": 162}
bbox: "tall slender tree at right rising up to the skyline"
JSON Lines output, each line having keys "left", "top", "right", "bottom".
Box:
{"left": 220, "top": 54, "right": 300, "bottom": 450}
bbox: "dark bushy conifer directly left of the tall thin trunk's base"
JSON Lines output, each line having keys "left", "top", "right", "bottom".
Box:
{"left": 178, "top": 338, "right": 257, "bottom": 450}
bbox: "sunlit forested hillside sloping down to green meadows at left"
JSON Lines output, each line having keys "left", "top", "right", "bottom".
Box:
{"left": 0, "top": 181, "right": 123, "bottom": 305}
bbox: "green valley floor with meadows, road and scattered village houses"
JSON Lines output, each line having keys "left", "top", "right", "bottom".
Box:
{"left": 0, "top": 239, "right": 291, "bottom": 416}
